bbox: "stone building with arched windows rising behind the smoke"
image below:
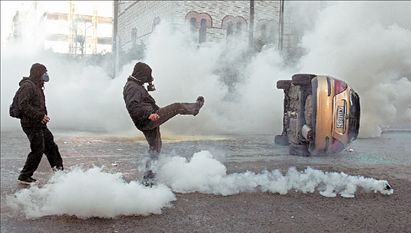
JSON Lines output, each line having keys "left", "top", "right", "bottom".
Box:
{"left": 113, "top": 1, "right": 293, "bottom": 52}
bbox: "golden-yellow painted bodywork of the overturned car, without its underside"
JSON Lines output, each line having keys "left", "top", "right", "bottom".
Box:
{"left": 309, "top": 76, "right": 360, "bottom": 154}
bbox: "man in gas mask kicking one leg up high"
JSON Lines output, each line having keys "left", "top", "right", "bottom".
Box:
{"left": 123, "top": 62, "right": 204, "bottom": 186}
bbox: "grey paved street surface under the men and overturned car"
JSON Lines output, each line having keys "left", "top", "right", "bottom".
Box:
{"left": 1, "top": 131, "right": 411, "bottom": 232}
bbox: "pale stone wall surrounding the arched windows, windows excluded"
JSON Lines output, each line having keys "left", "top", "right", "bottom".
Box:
{"left": 118, "top": 1, "right": 279, "bottom": 51}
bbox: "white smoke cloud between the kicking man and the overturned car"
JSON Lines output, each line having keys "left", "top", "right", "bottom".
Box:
{"left": 146, "top": 23, "right": 291, "bottom": 134}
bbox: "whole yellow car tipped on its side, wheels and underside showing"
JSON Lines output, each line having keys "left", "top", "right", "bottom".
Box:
{"left": 275, "top": 74, "right": 360, "bottom": 156}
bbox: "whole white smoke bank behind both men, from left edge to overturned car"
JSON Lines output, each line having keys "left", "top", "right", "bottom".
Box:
{"left": 1, "top": 19, "right": 291, "bottom": 134}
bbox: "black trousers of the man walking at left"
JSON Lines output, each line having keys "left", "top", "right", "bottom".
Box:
{"left": 20, "top": 127, "right": 63, "bottom": 177}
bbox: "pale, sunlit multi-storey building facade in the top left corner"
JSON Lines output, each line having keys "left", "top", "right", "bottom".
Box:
{"left": 12, "top": 1, "right": 113, "bottom": 56}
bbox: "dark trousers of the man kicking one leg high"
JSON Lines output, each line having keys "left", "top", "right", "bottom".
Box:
{"left": 141, "top": 103, "right": 200, "bottom": 157}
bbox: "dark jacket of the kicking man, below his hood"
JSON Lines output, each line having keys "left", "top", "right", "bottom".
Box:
{"left": 123, "top": 77, "right": 159, "bottom": 130}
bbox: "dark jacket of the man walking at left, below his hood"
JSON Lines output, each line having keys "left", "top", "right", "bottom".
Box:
{"left": 16, "top": 77, "right": 47, "bottom": 127}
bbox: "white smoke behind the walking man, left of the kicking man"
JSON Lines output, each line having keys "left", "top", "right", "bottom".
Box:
{"left": 1, "top": 46, "right": 133, "bottom": 132}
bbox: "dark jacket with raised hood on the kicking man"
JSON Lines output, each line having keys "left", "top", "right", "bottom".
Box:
{"left": 123, "top": 62, "right": 159, "bottom": 130}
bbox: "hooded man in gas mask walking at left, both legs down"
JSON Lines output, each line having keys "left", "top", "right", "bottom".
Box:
{"left": 10, "top": 63, "right": 63, "bottom": 184}
